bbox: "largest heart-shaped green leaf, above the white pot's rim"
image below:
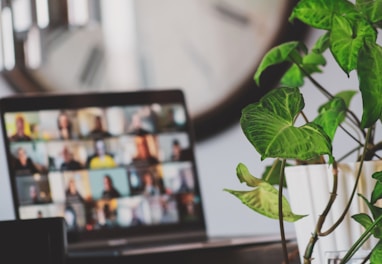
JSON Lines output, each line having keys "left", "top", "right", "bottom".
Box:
{"left": 240, "top": 87, "right": 331, "bottom": 160}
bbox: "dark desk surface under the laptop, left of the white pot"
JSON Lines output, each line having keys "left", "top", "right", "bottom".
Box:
{"left": 67, "top": 238, "right": 300, "bottom": 264}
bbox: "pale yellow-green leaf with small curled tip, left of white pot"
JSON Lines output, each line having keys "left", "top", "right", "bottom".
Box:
{"left": 224, "top": 164, "right": 304, "bottom": 222}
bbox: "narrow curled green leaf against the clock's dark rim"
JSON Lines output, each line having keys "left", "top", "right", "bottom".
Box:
{"left": 254, "top": 41, "right": 300, "bottom": 85}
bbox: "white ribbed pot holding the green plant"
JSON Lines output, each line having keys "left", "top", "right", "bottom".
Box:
{"left": 285, "top": 161, "right": 382, "bottom": 264}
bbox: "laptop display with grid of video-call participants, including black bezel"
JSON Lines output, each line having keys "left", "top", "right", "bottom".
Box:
{"left": 0, "top": 90, "right": 205, "bottom": 248}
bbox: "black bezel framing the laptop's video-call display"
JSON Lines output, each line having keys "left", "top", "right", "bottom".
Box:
{"left": 0, "top": 89, "right": 207, "bottom": 243}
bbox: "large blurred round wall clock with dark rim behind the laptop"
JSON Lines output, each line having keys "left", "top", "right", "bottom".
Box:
{"left": 0, "top": 0, "right": 304, "bottom": 140}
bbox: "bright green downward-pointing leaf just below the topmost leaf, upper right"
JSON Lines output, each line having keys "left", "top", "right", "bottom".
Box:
{"left": 330, "top": 16, "right": 376, "bottom": 74}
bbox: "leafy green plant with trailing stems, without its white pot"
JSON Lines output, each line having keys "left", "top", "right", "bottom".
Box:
{"left": 225, "top": 0, "right": 382, "bottom": 263}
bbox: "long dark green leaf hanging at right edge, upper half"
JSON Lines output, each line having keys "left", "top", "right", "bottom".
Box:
{"left": 358, "top": 42, "right": 382, "bottom": 128}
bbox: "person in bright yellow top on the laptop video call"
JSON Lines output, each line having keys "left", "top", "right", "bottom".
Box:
{"left": 88, "top": 139, "right": 117, "bottom": 169}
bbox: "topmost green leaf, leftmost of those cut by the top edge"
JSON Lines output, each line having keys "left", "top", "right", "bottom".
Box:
{"left": 289, "top": 0, "right": 360, "bottom": 30}
